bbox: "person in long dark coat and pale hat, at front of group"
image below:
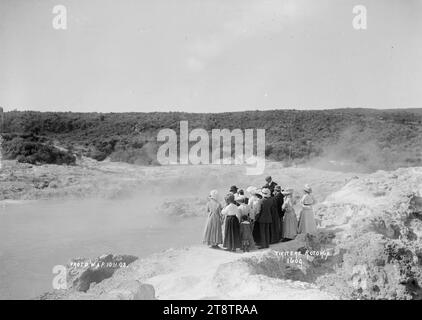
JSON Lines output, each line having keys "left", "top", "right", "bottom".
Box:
{"left": 253, "top": 188, "right": 275, "bottom": 249}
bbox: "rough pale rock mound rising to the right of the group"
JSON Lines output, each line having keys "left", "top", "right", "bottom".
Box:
{"left": 317, "top": 168, "right": 422, "bottom": 299}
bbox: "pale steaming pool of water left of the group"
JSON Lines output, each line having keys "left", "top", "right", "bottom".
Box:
{"left": 0, "top": 199, "right": 205, "bottom": 299}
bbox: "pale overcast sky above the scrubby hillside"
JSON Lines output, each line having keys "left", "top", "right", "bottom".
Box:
{"left": 0, "top": 0, "right": 422, "bottom": 112}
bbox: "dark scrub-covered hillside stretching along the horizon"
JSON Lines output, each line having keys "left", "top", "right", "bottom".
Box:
{"left": 2, "top": 109, "right": 422, "bottom": 171}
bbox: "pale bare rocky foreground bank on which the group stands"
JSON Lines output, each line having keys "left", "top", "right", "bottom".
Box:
{"left": 33, "top": 165, "right": 422, "bottom": 299}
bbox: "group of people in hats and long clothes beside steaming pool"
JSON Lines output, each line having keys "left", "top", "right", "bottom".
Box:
{"left": 203, "top": 176, "right": 317, "bottom": 252}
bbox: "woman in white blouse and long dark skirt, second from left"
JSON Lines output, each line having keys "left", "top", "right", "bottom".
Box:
{"left": 221, "top": 193, "right": 241, "bottom": 251}
